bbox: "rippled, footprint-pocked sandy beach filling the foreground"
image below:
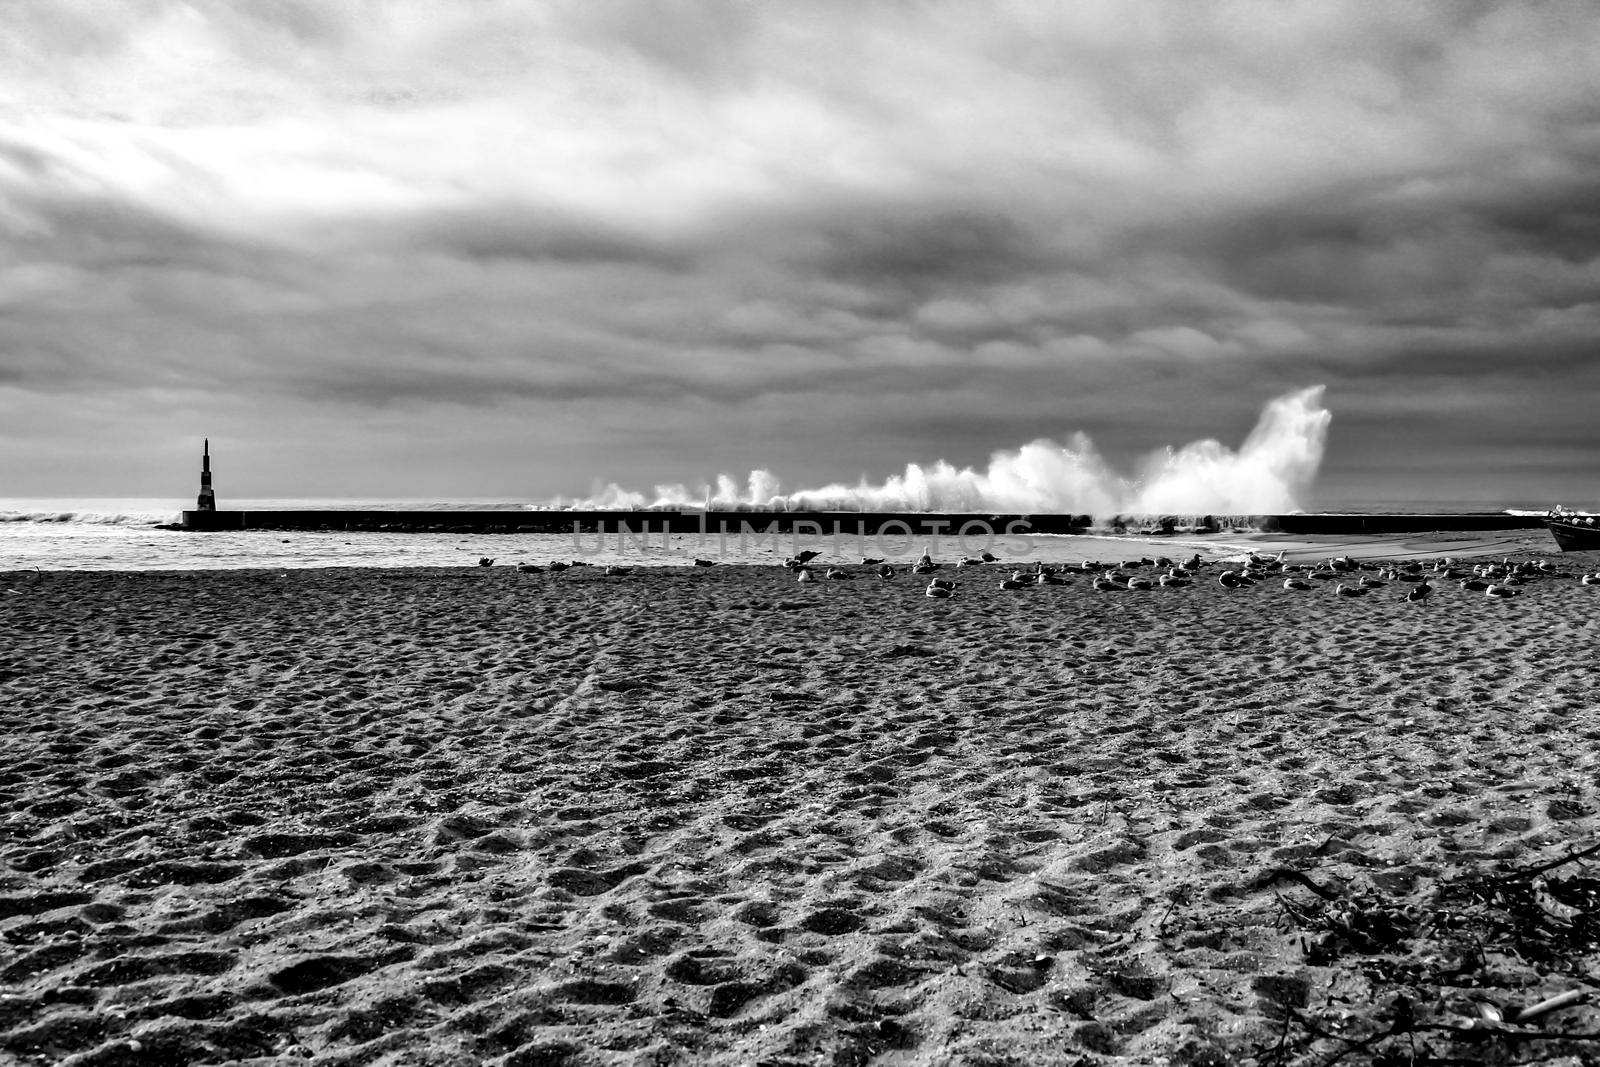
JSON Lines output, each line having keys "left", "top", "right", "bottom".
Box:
{"left": 0, "top": 556, "right": 1600, "bottom": 1067}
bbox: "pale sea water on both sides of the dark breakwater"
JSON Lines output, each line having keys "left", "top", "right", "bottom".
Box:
{"left": 0, "top": 498, "right": 1542, "bottom": 573}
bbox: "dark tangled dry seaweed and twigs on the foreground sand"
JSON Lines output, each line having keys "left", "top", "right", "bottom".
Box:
{"left": 1256, "top": 845, "right": 1600, "bottom": 1067}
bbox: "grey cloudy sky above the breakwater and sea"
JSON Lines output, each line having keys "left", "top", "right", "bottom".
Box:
{"left": 0, "top": 0, "right": 1600, "bottom": 507}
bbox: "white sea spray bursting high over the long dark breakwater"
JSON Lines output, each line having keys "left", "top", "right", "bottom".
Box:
{"left": 576, "top": 386, "right": 1333, "bottom": 517}
